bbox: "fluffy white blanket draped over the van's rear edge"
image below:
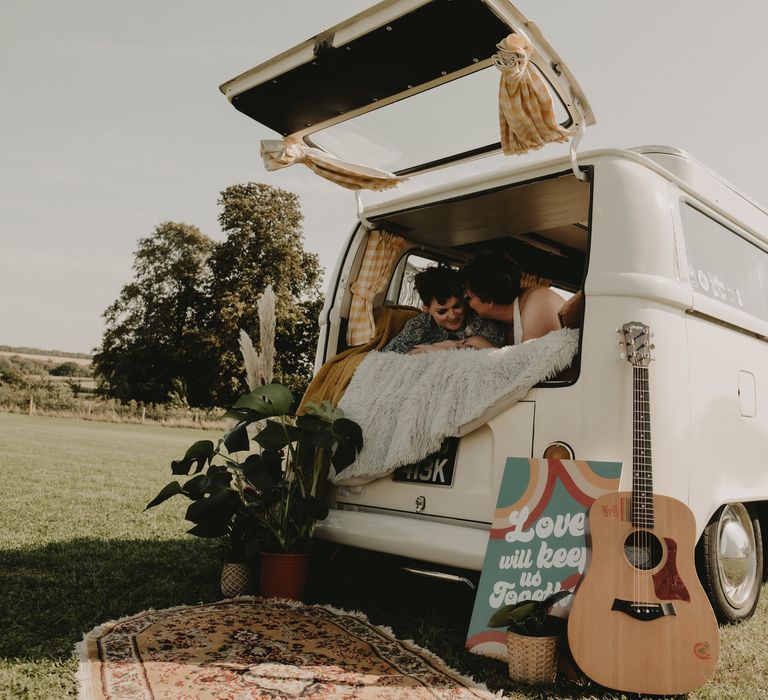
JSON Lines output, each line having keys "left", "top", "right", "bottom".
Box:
{"left": 330, "top": 328, "right": 579, "bottom": 484}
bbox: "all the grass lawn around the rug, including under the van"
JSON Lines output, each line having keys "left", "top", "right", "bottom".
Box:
{"left": 0, "top": 413, "right": 768, "bottom": 699}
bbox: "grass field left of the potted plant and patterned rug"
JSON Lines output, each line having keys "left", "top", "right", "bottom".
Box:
{"left": 0, "top": 413, "right": 220, "bottom": 698}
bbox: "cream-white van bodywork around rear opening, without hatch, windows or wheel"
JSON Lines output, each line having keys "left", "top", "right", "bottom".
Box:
{"left": 317, "top": 147, "right": 768, "bottom": 569}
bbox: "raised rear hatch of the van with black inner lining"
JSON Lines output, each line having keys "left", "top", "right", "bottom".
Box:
{"left": 220, "top": 0, "right": 595, "bottom": 175}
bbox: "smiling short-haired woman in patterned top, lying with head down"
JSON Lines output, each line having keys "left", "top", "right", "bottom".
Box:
{"left": 382, "top": 266, "right": 504, "bottom": 354}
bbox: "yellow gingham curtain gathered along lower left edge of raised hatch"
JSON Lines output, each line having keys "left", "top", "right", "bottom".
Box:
{"left": 261, "top": 139, "right": 405, "bottom": 190}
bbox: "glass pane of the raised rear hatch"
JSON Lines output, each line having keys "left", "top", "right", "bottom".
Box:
{"left": 310, "top": 66, "right": 570, "bottom": 172}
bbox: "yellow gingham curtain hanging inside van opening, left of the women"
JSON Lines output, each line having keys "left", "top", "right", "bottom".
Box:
{"left": 347, "top": 231, "right": 406, "bottom": 346}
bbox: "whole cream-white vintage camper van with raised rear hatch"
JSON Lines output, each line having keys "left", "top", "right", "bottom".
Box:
{"left": 222, "top": 0, "right": 768, "bottom": 620}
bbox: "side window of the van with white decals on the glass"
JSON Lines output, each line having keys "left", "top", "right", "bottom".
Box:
{"left": 682, "top": 205, "right": 768, "bottom": 320}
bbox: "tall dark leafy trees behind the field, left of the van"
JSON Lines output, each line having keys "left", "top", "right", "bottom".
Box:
{"left": 93, "top": 183, "right": 323, "bottom": 407}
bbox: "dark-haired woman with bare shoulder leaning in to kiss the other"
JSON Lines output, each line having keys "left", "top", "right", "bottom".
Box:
{"left": 461, "top": 253, "right": 563, "bottom": 347}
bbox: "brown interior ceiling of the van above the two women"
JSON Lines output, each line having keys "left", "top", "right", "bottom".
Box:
{"left": 371, "top": 171, "right": 591, "bottom": 291}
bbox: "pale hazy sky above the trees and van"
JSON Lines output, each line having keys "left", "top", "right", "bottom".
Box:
{"left": 0, "top": 0, "right": 768, "bottom": 352}
